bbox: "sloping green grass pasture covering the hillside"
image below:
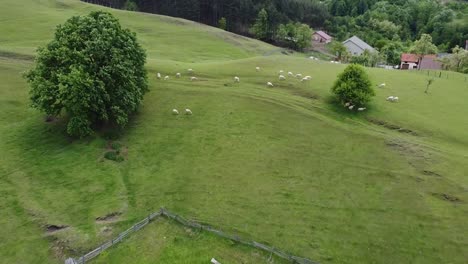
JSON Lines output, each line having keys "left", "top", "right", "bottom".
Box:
{"left": 0, "top": 0, "right": 468, "bottom": 263}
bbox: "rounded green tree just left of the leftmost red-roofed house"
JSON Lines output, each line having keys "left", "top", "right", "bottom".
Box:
{"left": 275, "top": 23, "right": 312, "bottom": 51}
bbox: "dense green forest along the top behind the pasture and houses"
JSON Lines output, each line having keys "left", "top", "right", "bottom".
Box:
{"left": 85, "top": 0, "right": 468, "bottom": 52}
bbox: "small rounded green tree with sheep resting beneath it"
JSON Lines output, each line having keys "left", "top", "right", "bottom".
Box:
{"left": 331, "top": 64, "right": 375, "bottom": 106}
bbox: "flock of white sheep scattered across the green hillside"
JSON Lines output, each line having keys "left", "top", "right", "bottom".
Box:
{"left": 156, "top": 66, "right": 399, "bottom": 115}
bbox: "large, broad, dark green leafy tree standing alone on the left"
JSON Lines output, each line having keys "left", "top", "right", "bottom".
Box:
{"left": 26, "top": 11, "right": 148, "bottom": 137}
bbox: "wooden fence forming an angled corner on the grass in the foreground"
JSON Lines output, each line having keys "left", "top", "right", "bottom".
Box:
{"left": 65, "top": 208, "right": 318, "bottom": 264}
